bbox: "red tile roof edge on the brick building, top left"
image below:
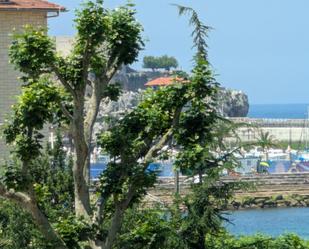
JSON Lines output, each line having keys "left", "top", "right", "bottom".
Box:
{"left": 0, "top": 0, "right": 65, "bottom": 11}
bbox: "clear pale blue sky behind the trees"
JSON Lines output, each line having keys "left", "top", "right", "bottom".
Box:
{"left": 49, "top": 0, "right": 309, "bottom": 104}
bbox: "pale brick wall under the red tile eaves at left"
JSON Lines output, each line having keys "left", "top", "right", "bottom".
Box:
{"left": 0, "top": 11, "right": 47, "bottom": 158}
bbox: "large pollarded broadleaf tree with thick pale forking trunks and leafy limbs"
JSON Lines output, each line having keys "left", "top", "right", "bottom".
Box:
{"left": 0, "top": 0, "right": 236, "bottom": 249}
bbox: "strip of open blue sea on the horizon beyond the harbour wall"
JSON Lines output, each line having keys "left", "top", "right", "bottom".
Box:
{"left": 248, "top": 104, "right": 309, "bottom": 119}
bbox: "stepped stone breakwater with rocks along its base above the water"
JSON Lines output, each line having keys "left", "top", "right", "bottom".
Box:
{"left": 145, "top": 173, "right": 309, "bottom": 210}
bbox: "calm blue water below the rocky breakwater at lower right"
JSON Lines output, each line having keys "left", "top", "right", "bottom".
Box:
{"left": 226, "top": 208, "right": 309, "bottom": 239}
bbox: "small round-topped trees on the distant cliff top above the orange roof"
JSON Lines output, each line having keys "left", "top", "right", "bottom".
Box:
{"left": 143, "top": 55, "right": 178, "bottom": 71}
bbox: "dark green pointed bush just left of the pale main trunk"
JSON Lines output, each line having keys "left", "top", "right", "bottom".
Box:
{"left": 30, "top": 131, "right": 74, "bottom": 220}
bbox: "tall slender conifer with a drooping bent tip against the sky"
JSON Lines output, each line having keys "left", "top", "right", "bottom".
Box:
{"left": 168, "top": 5, "right": 240, "bottom": 249}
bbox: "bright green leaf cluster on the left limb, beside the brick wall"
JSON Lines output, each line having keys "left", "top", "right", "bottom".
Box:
{"left": 4, "top": 77, "right": 62, "bottom": 162}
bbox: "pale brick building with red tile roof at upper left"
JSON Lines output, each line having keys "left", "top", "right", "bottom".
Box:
{"left": 0, "top": 0, "right": 65, "bottom": 159}
